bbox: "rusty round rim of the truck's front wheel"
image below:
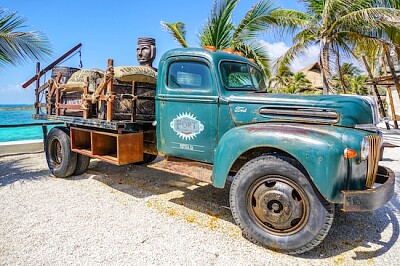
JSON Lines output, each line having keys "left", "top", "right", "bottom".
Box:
{"left": 247, "top": 176, "right": 310, "bottom": 235}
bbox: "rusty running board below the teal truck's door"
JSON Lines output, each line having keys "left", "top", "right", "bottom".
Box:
{"left": 147, "top": 157, "right": 212, "bottom": 183}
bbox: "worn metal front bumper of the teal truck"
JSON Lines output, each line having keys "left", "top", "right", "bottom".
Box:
{"left": 342, "top": 166, "right": 395, "bottom": 212}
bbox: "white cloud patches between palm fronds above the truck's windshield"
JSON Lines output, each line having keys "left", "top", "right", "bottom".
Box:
{"left": 262, "top": 41, "right": 319, "bottom": 72}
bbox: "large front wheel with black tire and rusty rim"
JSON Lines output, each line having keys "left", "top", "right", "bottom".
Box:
{"left": 229, "top": 155, "right": 334, "bottom": 254}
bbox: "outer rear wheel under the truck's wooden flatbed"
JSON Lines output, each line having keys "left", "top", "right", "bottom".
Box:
{"left": 45, "top": 127, "right": 77, "bottom": 178}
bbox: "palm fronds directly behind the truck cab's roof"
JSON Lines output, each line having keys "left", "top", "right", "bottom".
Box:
{"left": 161, "top": 0, "right": 276, "bottom": 77}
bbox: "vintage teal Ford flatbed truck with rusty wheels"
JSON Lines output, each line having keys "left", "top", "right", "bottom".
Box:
{"left": 36, "top": 48, "right": 395, "bottom": 254}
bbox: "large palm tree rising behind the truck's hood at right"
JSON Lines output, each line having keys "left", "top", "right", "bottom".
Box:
{"left": 272, "top": 0, "right": 400, "bottom": 94}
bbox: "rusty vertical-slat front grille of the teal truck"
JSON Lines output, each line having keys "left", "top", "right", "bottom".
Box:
{"left": 366, "top": 136, "right": 381, "bottom": 188}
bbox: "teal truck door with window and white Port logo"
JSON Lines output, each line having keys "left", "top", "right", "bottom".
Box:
{"left": 156, "top": 57, "right": 218, "bottom": 163}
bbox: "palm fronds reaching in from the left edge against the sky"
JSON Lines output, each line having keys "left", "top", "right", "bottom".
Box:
{"left": 0, "top": 9, "right": 51, "bottom": 68}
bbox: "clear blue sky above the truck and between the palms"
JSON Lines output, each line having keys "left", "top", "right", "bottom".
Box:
{"left": 0, "top": 0, "right": 316, "bottom": 104}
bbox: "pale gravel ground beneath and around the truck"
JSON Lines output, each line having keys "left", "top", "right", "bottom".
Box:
{"left": 0, "top": 130, "right": 400, "bottom": 265}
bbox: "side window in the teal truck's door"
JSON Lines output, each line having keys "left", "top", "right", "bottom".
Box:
{"left": 167, "top": 61, "right": 211, "bottom": 91}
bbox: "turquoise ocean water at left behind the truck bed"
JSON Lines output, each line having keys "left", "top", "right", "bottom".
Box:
{"left": 0, "top": 104, "right": 51, "bottom": 142}
